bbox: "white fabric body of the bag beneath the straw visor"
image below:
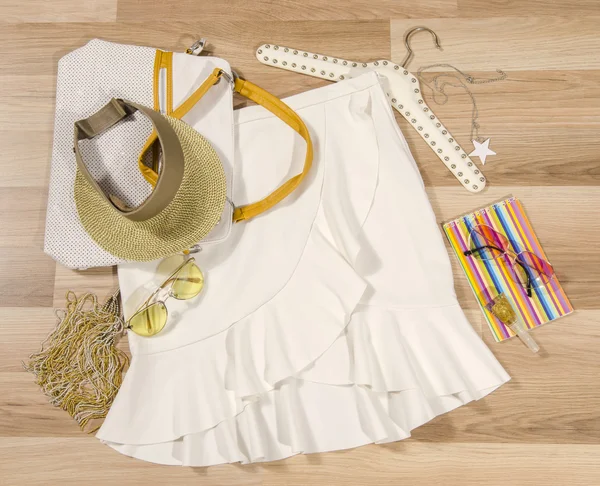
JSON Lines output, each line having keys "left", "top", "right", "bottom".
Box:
{"left": 44, "top": 39, "right": 234, "bottom": 268}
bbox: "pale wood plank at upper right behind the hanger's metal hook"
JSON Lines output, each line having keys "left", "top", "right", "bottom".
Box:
{"left": 391, "top": 15, "right": 600, "bottom": 72}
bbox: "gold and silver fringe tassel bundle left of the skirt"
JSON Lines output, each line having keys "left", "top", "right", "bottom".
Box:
{"left": 24, "top": 290, "right": 129, "bottom": 433}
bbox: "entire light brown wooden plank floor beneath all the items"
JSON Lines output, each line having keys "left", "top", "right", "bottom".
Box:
{"left": 0, "top": 0, "right": 600, "bottom": 486}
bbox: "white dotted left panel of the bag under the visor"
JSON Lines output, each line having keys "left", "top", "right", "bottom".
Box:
{"left": 44, "top": 39, "right": 156, "bottom": 268}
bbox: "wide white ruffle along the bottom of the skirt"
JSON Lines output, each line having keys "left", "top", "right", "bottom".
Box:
{"left": 98, "top": 302, "right": 509, "bottom": 466}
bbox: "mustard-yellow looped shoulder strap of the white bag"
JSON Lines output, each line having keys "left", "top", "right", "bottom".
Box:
{"left": 138, "top": 68, "right": 313, "bottom": 223}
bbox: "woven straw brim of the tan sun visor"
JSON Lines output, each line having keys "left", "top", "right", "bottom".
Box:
{"left": 74, "top": 116, "right": 227, "bottom": 261}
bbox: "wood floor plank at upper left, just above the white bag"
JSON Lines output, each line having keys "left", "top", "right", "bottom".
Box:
{"left": 0, "top": 20, "right": 390, "bottom": 78}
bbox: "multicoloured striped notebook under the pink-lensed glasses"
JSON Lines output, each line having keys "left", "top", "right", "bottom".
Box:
{"left": 444, "top": 198, "right": 573, "bottom": 341}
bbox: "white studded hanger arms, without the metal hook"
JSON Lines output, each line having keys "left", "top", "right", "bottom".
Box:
{"left": 256, "top": 44, "right": 486, "bottom": 192}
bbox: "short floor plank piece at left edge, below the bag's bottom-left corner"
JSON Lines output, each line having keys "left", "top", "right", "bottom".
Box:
{"left": 0, "top": 247, "right": 55, "bottom": 307}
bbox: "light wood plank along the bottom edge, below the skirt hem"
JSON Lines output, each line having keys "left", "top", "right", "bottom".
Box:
{"left": 0, "top": 437, "right": 600, "bottom": 486}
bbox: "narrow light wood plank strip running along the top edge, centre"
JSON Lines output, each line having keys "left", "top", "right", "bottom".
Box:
{"left": 118, "top": 0, "right": 457, "bottom": 21}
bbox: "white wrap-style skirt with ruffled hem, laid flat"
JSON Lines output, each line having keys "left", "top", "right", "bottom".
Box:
{"left": 97, "top": 73, "right": 509, "bottom": 466}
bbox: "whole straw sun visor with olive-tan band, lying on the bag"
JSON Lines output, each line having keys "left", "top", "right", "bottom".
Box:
{"left": 74, "top": 99, "right": 227, "bottom": 261}
